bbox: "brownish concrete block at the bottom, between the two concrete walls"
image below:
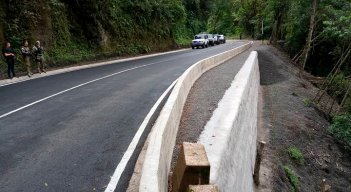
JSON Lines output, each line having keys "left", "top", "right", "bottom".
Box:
{"left": 172, "top": 142, "right": 210, "bottom": 192}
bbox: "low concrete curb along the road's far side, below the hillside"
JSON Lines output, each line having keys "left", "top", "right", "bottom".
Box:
{"left": 0, "top": 49, "right": 189, "bottom": 87}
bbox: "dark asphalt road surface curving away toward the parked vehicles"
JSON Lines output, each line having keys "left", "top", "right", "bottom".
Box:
{"left": 0, "top": 42, "right": 248, "bottom": 192}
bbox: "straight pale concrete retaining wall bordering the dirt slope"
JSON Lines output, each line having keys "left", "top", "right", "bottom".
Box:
{"left": 199, "top": 51, "right": 260, "bottom": 192}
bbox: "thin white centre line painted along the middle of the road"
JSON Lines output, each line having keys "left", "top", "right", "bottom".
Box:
{"left": 0, "top": 59, "right": 176, "bottom": 119}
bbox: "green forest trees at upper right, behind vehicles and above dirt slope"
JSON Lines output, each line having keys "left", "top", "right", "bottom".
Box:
{"left": 208, "top": 0, "right": 351, "bottom": 116}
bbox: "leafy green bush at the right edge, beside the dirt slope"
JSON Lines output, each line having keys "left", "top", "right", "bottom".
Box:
{"left": 328, "top": 114, "right": 351, "bottom": 150}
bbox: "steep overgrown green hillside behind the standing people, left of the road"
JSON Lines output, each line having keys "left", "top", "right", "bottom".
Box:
{"left": 0, "top": 0, "right": 212, "bottom": 76}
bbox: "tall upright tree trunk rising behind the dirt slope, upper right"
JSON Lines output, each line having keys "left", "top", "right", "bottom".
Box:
{"left": 302, "top": 0, "right": 319, "bottom": 70}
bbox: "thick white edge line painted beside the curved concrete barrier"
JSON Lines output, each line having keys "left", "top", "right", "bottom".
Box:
{"left": 105, "top": 80, "right": 177, "bottom": 192}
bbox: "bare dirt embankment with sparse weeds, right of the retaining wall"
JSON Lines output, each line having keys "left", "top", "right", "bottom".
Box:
{"left": 256, "top": 46, "right": 351, "bottom": 192}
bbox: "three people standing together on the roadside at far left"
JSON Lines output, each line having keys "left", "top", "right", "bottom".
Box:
{"left": 2, "top": 40, "right": 46, "bottom": 79}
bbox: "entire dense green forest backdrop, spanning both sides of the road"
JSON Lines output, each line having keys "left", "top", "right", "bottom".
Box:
{"left": 0, "top": 0, "right": 351, "bottom": 115}
